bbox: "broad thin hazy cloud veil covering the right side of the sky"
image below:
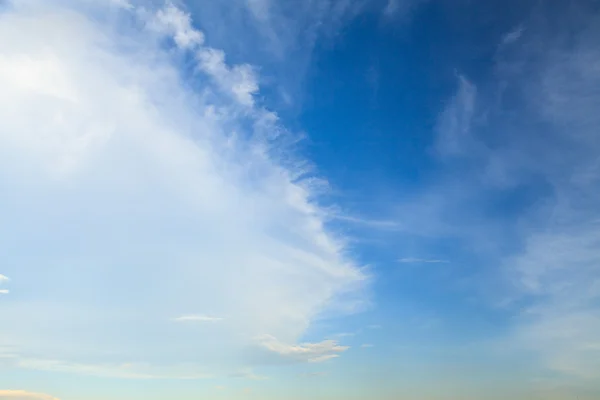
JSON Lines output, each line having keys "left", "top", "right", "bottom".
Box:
{"left": 423, "top": 2, "right": 600, "bottom": 384}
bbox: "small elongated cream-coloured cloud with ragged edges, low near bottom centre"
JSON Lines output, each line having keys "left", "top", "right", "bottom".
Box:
{"left": 258, "top": 335, "right": 350, "bottom": 362}
